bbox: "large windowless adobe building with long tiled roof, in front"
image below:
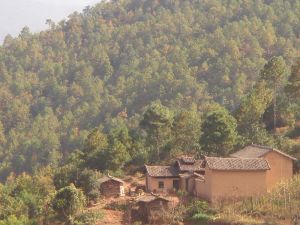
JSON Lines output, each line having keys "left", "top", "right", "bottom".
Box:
{"left": 195, "top": 157, "right": 270, "bottom": 202}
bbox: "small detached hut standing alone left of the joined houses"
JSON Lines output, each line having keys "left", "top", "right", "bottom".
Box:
{"left": 98, "top": 175, "right": 125, "bottom": 197}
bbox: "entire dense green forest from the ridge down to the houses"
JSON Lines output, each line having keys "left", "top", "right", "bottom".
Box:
{"left": 0, "top": 0, "right": 300, "bottom": 224}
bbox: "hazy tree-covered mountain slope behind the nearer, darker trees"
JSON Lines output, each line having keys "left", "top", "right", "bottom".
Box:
{"left": 0, "top": 0, "right": 300, "bottom": 178}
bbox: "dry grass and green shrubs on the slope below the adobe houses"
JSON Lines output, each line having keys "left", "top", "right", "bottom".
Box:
{"left": 133, "top": 175, "right": 300, "bottom": 225}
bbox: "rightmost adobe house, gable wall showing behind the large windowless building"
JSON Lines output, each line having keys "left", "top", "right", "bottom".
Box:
{"left": 230, "top": 144, "right": 297, "bottom": 190}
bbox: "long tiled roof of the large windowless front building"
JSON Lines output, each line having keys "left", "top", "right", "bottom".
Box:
{"left": 205, "top": 157, "right": 270, "bottom": 171}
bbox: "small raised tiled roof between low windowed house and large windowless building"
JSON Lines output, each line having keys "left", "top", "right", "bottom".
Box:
{"left": 176, "top": 157, "right": 204, "bottom": 172}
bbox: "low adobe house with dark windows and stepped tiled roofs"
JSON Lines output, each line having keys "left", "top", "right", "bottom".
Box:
{"left": 145, "top": 157, "right": 204, "bottom": 194}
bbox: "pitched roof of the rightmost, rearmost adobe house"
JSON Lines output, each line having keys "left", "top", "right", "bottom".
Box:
{"left": 230, "top": 144, "right": 297, "bottom": 160}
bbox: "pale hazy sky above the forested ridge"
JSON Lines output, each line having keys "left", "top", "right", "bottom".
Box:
{"left": 0, "top": 0, "right": 100, "bottom": 43}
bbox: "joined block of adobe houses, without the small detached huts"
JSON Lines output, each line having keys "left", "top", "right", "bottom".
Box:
{"left": 146, "top": 144, "right": 296, "bottom": 202}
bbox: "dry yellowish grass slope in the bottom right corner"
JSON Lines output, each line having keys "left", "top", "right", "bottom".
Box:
{"left": 215, "top": 175, "right": 300, "bottom": 225}
